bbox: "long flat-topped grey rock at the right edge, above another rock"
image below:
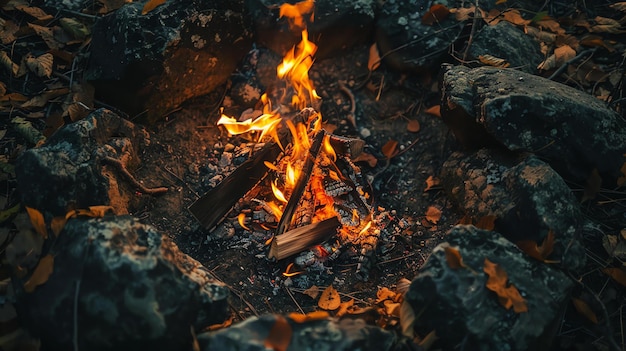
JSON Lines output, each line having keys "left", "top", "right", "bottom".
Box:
{"left": 441, "top": 65, "right": 626, "bottom": 187}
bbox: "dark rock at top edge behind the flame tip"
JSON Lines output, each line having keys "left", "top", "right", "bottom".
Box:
{"left": 247, "top": 0, "right": 378, "bottom": 59}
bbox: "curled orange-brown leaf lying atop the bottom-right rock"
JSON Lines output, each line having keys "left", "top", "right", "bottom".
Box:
{"left": 483, "top": 258, "right": 528, "bottom": 313}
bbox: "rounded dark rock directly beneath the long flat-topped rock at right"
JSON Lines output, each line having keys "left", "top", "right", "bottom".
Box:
{"left": 441, "top": 149, "right": 586, "bottom": 271}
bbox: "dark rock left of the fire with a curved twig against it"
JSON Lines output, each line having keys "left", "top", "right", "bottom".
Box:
{"left": 15, "top": 109, "right": 148, "bottom": 221}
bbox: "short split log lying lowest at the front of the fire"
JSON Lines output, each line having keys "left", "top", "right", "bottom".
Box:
{"left": 268, "top": 217, "right": 341, "bottom": 260}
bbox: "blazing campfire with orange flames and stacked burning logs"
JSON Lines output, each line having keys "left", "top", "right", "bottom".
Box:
{"left": 190, "top": 0, "right": 385, "bottom": 280}
